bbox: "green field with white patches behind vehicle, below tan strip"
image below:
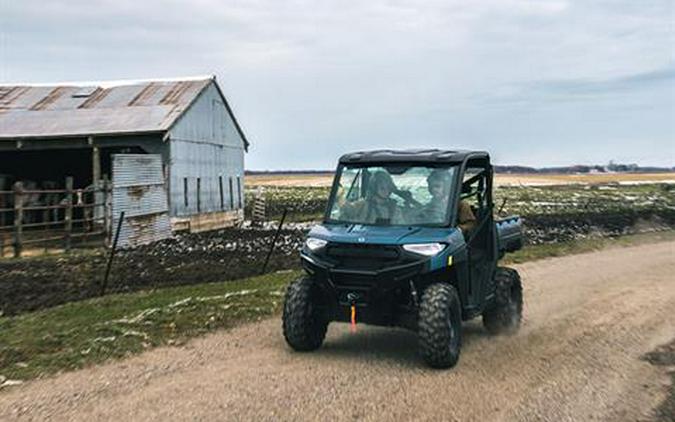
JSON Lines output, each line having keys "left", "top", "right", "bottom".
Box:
{"left": 246, "top": 173, "right": 675, "bottom": 232}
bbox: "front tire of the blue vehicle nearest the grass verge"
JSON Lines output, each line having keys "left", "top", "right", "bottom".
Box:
{"left": 282, "top": 276, "right": 328, "bottom": 352}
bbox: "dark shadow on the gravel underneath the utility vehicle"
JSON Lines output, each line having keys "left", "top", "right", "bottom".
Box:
{"left": 314, "top": 321, "right": 489, "bottom": 368}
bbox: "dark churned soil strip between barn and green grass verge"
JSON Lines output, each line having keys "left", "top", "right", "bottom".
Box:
{"left": 0, "top": 226, "right": 304, "bottom": 315}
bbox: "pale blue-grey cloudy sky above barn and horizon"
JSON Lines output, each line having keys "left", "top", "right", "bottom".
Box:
{"left": 0, "top": 0, "right": 675, "bottom": 169}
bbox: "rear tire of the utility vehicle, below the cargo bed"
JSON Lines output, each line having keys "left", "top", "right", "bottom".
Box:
{"left": 483, "top": 267, "right": 523, "bottom": 335}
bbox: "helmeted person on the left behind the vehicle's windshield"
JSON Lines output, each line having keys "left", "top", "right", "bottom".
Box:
{"left": 344, "top": 170, "right": 401, "bottom": 224}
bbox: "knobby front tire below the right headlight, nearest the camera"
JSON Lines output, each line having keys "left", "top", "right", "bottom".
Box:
{"left": 418, "top": 283, "right": 462, "bottom": 368}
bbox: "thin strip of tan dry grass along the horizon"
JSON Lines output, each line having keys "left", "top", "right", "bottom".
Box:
{"left": 246, "top": 172, "right": 675, "bottom": 187}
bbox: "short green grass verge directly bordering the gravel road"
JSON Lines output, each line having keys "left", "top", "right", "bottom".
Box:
{"left": 0, "top": 232, "right": 675, "bottom": 379}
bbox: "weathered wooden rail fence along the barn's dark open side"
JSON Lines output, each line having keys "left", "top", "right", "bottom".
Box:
{"left": 0, "top": 177, "right": 112, "bottom": 257}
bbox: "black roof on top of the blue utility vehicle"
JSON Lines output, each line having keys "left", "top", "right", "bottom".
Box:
{"left": 340, "top": 149, "right": 490, "bottom": 164}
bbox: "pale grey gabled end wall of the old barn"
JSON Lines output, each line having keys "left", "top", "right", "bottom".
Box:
{"left": 170, "top": 85, "right": 244, "bottom": 216}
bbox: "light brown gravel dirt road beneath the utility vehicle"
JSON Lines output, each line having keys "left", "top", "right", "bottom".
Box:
{"left": 0, "top": 242, "right": 675, "bottom": 421}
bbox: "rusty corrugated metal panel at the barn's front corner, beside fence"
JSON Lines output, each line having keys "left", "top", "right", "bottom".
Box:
{"left": 112, "top": 154, "right": 171, "bottom": 247}
